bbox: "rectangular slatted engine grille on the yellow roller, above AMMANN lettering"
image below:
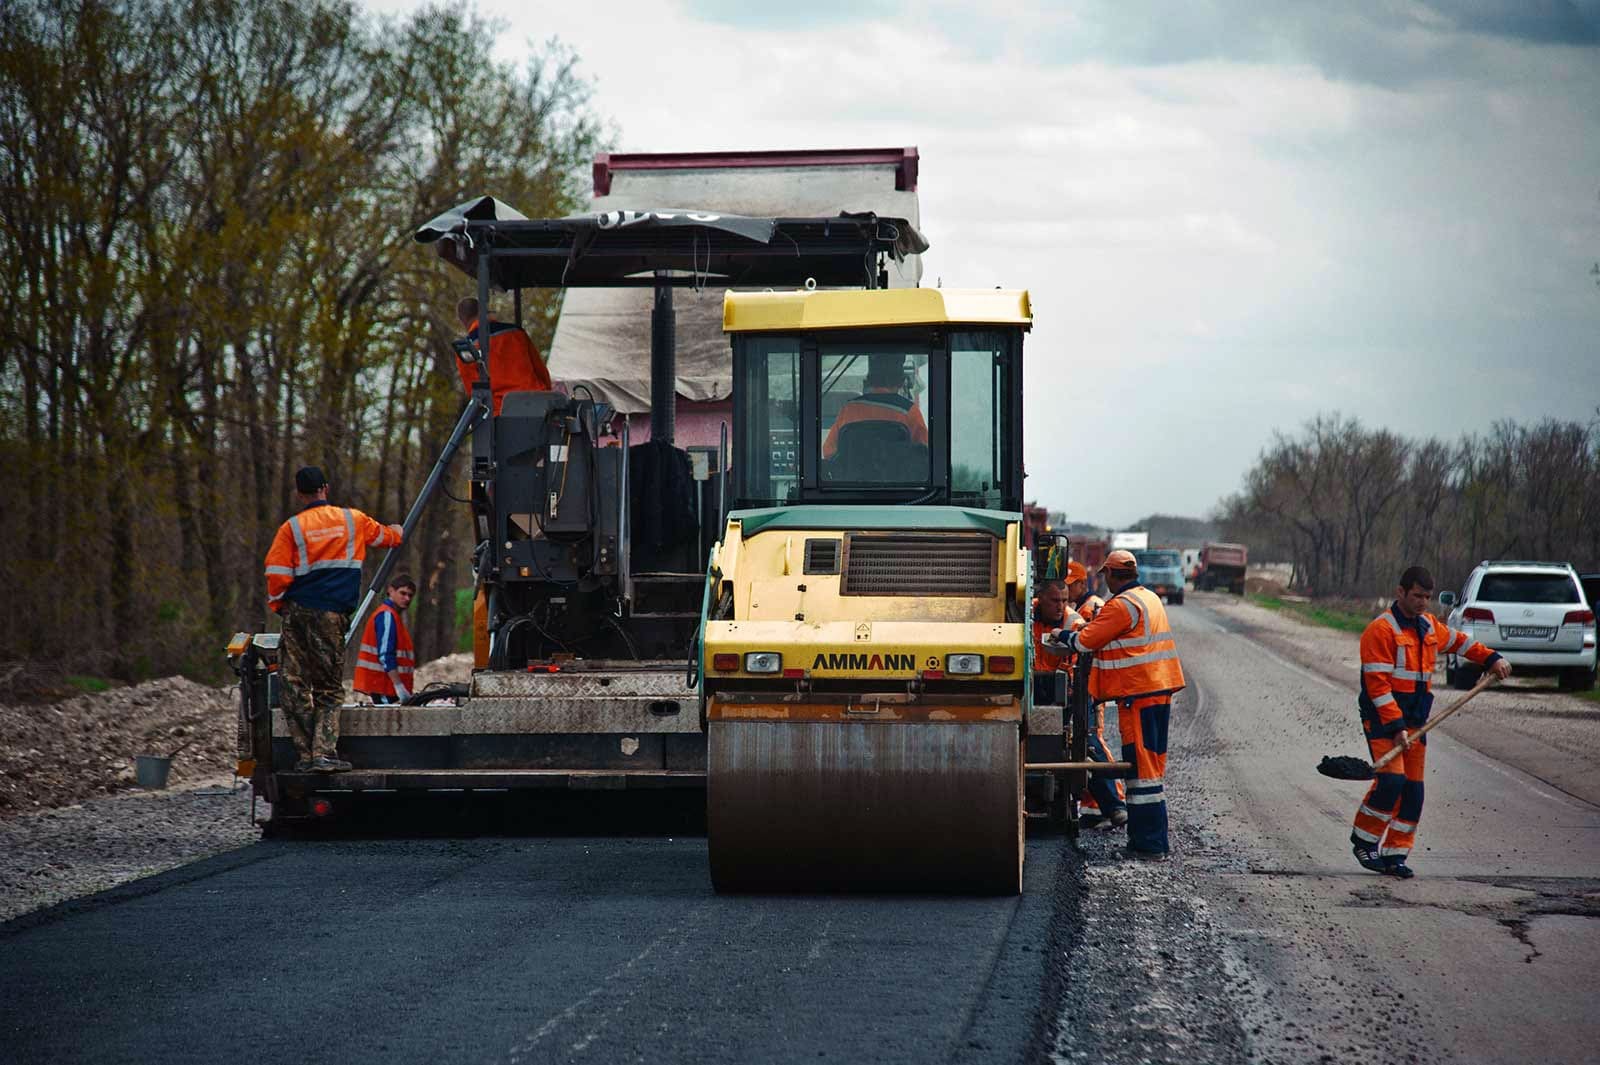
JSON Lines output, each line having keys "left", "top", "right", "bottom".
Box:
{"left": 838, "top": 533, "right": 995, "bottom": 596}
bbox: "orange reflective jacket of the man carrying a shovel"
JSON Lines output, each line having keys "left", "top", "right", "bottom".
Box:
{"left": 1357, "top": 603, "right": 1501, "bottom": 736}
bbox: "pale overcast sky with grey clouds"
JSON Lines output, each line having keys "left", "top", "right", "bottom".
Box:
{"left": 370, "top": 0, "right": 1600, "bottom": 525}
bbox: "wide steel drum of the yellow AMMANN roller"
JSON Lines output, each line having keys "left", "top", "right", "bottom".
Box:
{"left": 706, "top": 704, "right": 1022, "bottom": 894}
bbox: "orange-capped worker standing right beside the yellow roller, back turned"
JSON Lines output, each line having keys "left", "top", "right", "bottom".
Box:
{"left": 1054, "top": 550, "right": 1184, "bottom": 860}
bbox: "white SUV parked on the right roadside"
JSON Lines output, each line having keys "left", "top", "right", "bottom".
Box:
{"left": 1438, "top": 561, "right": 1595, "bottom": 691}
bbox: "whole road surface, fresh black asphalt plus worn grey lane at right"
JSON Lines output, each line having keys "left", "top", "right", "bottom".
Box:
{"left": 0, "top": 596, "right": 1600, "bottom": 1065}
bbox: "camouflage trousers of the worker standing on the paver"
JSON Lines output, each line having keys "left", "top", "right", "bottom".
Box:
{"left": 278, "top": 600, "right": 350, "bottom": 761}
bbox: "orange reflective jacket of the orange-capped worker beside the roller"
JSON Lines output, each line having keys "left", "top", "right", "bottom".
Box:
{"left": 1077, "top": 584, "right": 1184, "bottom": 702}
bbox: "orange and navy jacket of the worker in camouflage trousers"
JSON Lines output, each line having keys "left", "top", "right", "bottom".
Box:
{"left": 267, "top": 502, "right": 400, "bottom": 614}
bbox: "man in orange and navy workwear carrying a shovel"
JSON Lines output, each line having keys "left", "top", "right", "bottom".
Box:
{"left": 1350, "top": 566, "right": 1510, "bottom": 880}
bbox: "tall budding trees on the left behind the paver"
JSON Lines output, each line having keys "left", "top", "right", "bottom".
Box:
{"left": 0, "top": 0, "right": 605, "bottom": 678}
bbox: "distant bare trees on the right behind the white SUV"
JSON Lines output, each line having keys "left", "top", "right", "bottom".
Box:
{"left": 1216, "top": 414, "right": 1600, "bottom": 596}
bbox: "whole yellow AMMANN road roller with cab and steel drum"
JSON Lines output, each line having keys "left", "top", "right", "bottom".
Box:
{"left": 698, "top": 289, "right": 1032, "bottom": 892}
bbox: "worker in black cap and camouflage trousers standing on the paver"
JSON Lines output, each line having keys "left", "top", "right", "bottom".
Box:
{"left": 266, "top": 465, "right": 403, "bottom": 772}
